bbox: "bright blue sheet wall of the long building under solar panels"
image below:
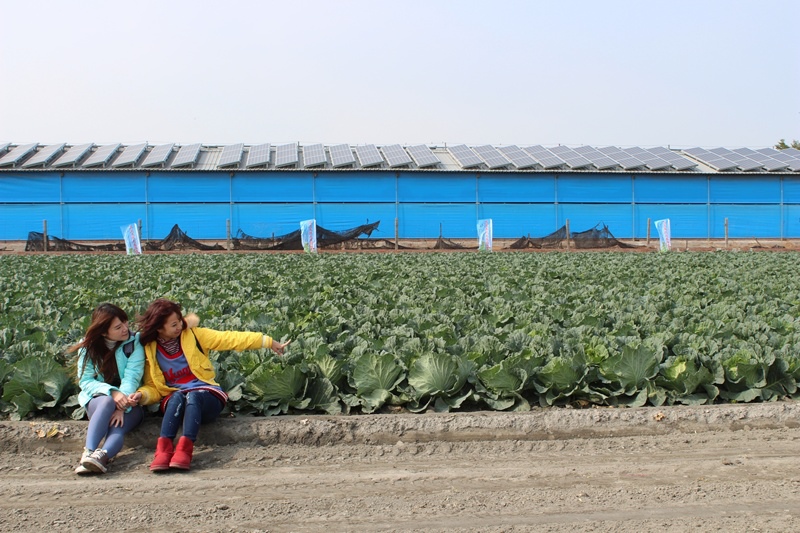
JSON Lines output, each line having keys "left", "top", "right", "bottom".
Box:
{"left": 0, "top": 170, "right": 800, "bottom": 240}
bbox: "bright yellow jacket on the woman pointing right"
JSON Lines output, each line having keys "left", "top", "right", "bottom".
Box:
{"left": 134, "top": 328, "right": 272, "bottom": 405}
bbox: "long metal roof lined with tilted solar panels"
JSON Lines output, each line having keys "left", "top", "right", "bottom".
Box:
{"left": 0, "top": 142, "right": 800, "bottom": 174}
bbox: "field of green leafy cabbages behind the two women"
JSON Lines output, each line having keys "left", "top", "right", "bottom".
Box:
{"left": 0, "top": 252, "right": 800, "bottom": 419}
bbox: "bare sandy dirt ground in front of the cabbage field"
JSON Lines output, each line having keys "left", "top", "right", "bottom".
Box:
{"left": 0, "top": 402, "right": 800, "bottom": 533}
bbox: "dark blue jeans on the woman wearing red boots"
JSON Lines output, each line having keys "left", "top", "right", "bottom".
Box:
{"left": 161, "top": 390, "right": 225, "bottom": 442}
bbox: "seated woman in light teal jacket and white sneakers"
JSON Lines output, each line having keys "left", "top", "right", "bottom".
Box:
{"left": 69, "top": 303, "right": 144, "bottom": 474}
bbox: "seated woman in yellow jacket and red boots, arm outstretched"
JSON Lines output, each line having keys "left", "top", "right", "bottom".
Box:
{"left": 132, "top": 299, "right": 289, "bottom": 472}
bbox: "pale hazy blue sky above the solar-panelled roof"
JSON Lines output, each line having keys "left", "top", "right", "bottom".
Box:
{"left": 0, "top": 0, "right": 800, "bottom": 148}
